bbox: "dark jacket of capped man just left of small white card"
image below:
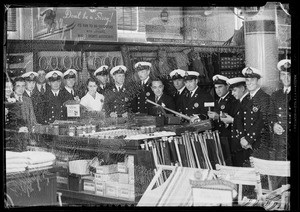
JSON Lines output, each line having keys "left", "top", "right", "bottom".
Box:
{"left": 182, "top": 87, "right": 214, "bottom": 120}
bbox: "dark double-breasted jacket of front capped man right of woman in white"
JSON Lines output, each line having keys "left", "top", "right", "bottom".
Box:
{"left": 103, "top": 85, "right": 131, "bottom": 117}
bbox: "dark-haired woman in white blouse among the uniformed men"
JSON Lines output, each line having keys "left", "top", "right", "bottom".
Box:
{"left": 80, "top": 78, "right": 104, "bottom": 111}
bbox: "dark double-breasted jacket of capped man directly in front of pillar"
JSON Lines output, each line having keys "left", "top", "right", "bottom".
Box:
{"left": 238, "top": 88, "right": 270, "bottom": 152}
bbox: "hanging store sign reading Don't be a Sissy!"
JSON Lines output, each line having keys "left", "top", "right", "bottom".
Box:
{"left": 32, "top": 7, "right": 117, "bottom": 41}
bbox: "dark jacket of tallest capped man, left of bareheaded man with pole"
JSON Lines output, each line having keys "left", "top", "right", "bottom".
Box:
{"left": 132, "top": 78, "right": 154, "bottom": 114}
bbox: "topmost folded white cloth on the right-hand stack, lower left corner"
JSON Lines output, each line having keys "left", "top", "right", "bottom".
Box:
{"left": 21, "top": 151, "right": 56, "bottom": 164}
